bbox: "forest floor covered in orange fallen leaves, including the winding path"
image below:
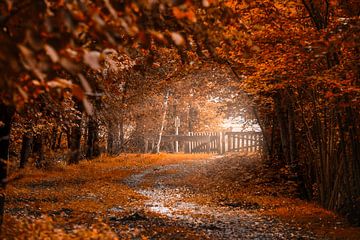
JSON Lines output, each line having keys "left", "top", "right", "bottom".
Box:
{"left": 0, "top": 154, "right": 360, "bottom": 240}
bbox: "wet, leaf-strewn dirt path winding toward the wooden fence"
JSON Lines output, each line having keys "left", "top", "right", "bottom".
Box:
{"left": 125, "top": 157, "right": 318, "bottom": 239}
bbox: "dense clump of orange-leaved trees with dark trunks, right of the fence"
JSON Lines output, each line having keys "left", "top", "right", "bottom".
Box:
{"left": 208, "top": 0, "right": 360, "bottom": 221}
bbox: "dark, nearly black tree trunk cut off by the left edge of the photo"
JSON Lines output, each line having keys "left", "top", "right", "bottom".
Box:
{"left": 0, "top": 103, "right": 15, "bottom": 226}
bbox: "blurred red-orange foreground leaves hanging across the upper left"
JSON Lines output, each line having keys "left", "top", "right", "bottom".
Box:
{"left": 0, "top": 0, "right": 208, "bottom": 109}
